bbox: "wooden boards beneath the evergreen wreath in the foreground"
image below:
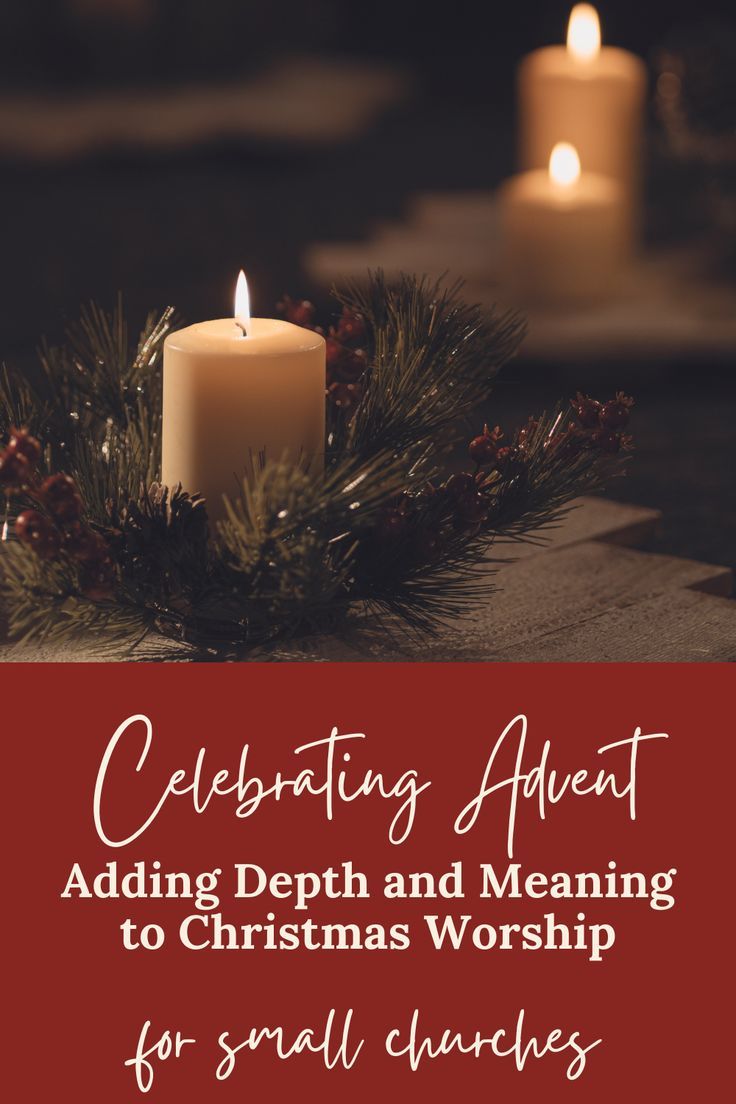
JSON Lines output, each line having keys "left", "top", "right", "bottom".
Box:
{"left": 0, "top": 498, "right": 736, "bottom": 662}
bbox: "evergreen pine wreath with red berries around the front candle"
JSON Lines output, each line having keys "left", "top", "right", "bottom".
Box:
{"left": 0, "top": 272, "right": 631, "bottom": 658}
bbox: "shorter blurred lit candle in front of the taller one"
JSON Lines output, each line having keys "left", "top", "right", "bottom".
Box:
{"left": 500, "top": 142, "right": 626, "bottom": 307}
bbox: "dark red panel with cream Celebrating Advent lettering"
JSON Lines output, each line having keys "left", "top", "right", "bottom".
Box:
{"left": 3, "top": 664, "right": 734, "bottom": 1104}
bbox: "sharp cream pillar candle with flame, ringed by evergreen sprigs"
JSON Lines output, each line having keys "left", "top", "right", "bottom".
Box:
{"left": 161, "top": 273, "right": 326, "bottom": 519}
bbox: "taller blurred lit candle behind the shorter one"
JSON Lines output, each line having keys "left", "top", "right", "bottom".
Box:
{"left": 519, "top": 3, "right": 647, "bottom": 234}
